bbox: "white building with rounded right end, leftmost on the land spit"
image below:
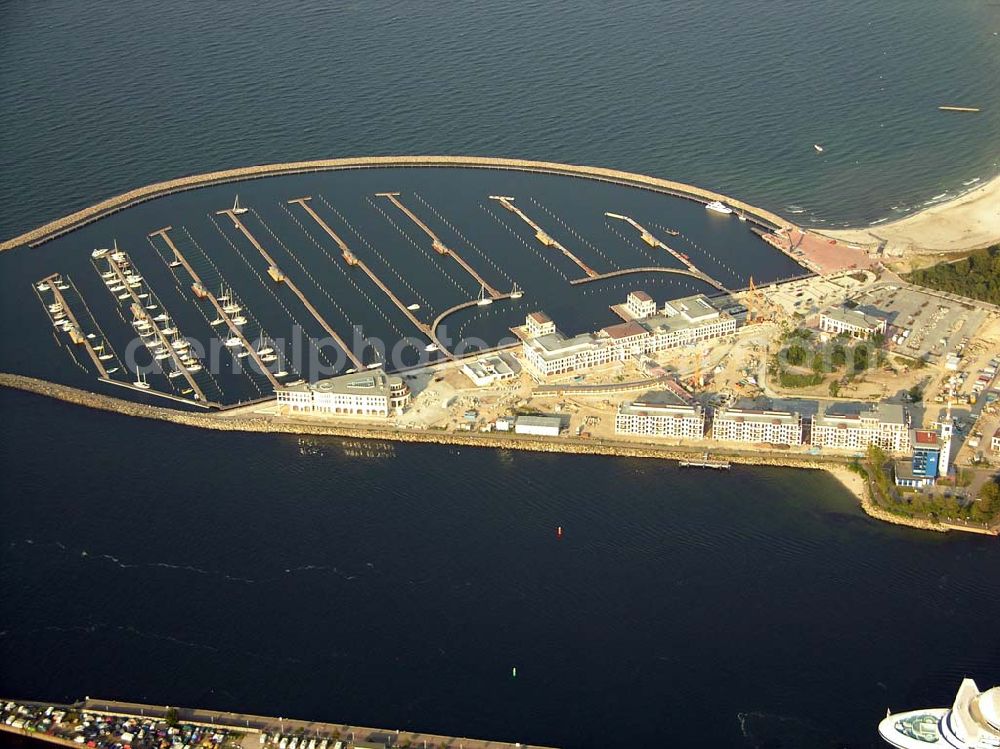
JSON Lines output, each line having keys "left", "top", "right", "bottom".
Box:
{"left": 274, "top": 369, "right": 410, "bottom": 418}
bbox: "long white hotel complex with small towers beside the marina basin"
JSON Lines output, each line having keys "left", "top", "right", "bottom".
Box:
{"left": 522, "top": 292, "right": 736, "bottom": 377}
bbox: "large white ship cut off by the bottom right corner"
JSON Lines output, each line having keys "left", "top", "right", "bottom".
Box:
{"left": 878, "top": 679, "right": 1000, "bottom": 749}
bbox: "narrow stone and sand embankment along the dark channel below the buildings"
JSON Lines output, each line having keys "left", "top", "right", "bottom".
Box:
{"left": 0, "top": 372, "right": 996, "bottom": 535}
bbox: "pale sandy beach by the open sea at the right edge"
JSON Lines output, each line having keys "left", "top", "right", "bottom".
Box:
{"left": 820, "top": 177, "right": 1000, "bottom": 258}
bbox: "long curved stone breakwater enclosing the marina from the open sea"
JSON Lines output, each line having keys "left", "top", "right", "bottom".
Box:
{"left": 0, "top": 156, "right": 797, "bottom": 251}
